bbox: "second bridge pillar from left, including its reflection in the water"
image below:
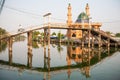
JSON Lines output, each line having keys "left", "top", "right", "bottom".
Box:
{"left": 27, "top": 31, "right": 32, "bottom": 68}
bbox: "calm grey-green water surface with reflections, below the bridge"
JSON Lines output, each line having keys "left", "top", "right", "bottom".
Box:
{"left": 0, "top": 41, "right": 120, "bottom": 80}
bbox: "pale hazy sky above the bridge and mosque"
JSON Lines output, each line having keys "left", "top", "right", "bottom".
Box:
{"left": 0, "top": 0, "right": 120, "bottom": 33}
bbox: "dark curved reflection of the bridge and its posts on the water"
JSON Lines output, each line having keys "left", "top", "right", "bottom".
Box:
{"left": 0, "top": 46, "right": 117, "bottom": 77}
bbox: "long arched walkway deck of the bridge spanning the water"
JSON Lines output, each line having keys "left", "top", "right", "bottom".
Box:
{"left": 0, "top": 23, "right": 118, "bottom": 43}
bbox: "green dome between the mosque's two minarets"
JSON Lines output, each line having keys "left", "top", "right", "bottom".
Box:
{"left": 76, "top": 12, "right": 89, "bottom": 23}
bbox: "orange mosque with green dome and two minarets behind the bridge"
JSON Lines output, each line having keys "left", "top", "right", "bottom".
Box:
{"left": 67, "top": 4, "right": 101, "bottom": 39}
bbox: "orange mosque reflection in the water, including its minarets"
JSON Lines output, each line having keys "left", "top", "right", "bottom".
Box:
{"left": 66, "top": 46, "right": 91, "bottom": 77}
